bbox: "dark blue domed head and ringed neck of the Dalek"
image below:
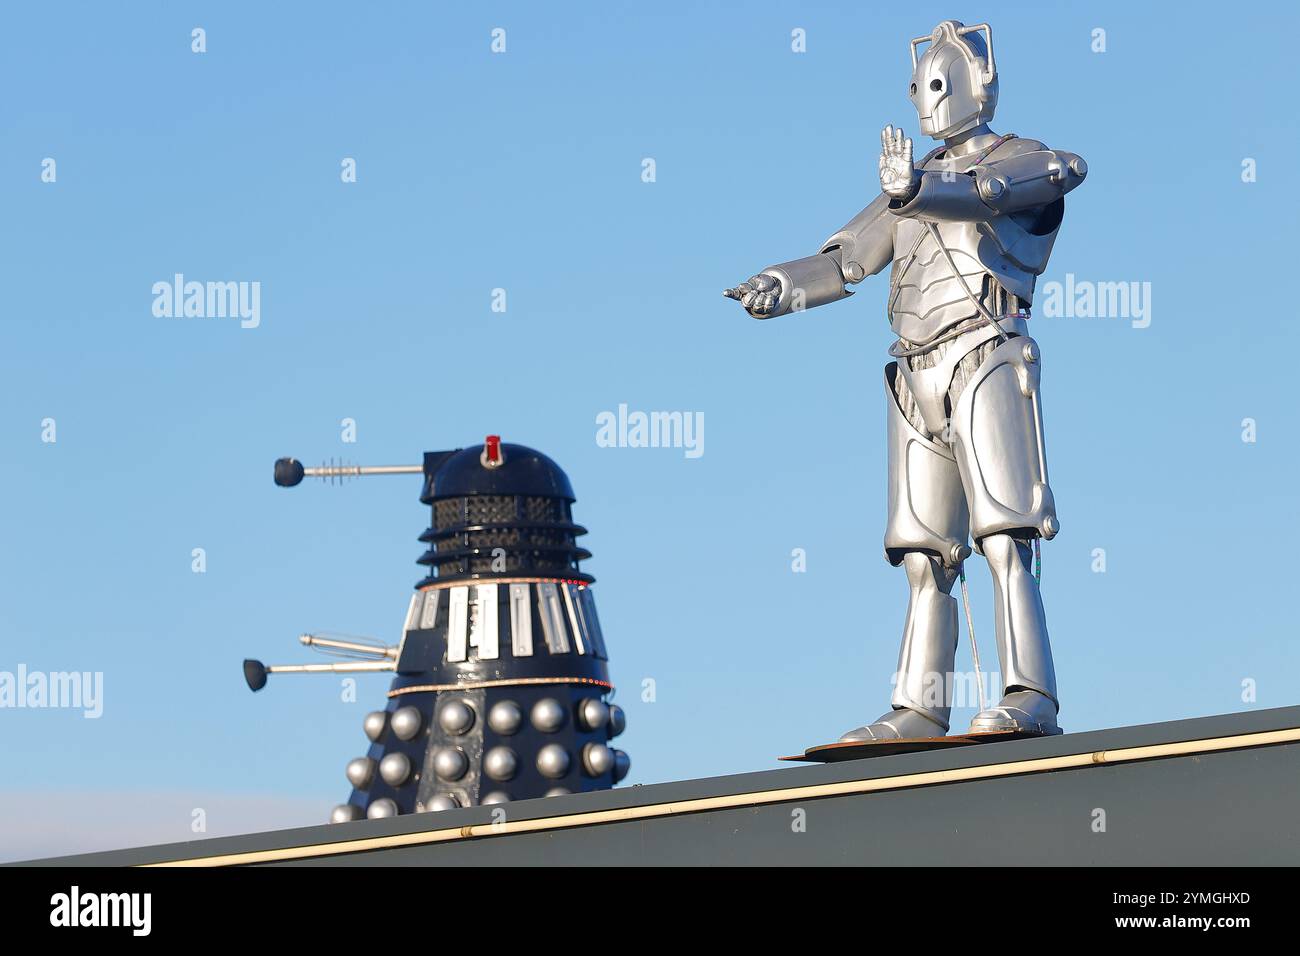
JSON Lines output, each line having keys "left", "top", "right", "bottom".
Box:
{"left": 417, "top": 436, "right": 595, "bottom": 587}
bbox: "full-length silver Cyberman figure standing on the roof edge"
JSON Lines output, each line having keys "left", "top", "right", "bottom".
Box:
{"left": 725, "top": 20, "right": 1087, "bottom": 740}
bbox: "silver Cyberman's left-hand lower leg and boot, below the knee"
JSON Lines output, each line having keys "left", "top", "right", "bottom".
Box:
{"left": 840, "top": 551, "right": 957, "bottom": 741}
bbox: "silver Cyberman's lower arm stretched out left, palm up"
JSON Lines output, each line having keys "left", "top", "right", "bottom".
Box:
{"left": 723, "top": 187, "right": 893, "bottom": 319}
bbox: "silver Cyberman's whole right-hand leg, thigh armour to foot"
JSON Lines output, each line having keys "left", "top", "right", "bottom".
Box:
{"left": 953, "top": 336, "right": 1061, "bottom": 734}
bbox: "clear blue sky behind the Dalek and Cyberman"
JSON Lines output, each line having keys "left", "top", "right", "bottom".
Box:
{"left": 0, "top": 3, "right": 1300, "bottom": 857}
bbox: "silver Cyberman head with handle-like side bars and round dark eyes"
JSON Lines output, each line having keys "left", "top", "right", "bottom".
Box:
{"left": 909, "top": 20, "right": 997, "bottom": 139}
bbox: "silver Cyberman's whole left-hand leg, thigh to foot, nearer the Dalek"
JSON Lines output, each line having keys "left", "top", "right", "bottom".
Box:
{"left": 840, "top": 364, "right": 970, "bottom": 740}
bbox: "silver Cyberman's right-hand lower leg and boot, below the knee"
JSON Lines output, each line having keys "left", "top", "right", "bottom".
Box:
{"left": 970, "top": 535, "right": 1061, "bottom": 736}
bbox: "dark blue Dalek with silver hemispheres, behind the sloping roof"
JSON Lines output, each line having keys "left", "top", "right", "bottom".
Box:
{"left": 244, "top": 436, "right": 631, "bottom": 823}
